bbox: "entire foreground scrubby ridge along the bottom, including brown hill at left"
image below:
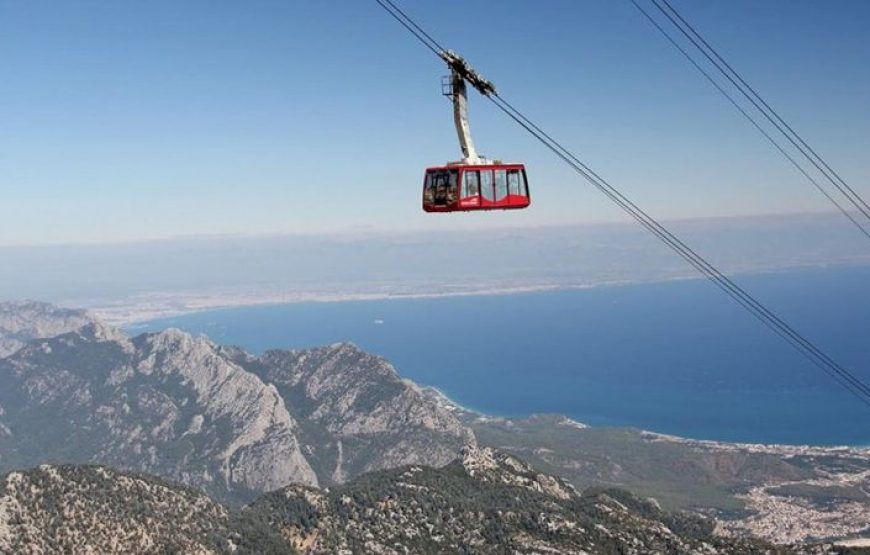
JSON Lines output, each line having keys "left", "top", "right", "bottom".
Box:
{"left": 0, "top": 456, "right": 816, "bottom": 555}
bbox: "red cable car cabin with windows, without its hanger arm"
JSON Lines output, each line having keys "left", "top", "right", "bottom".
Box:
{"left": 423, "top": 164, "right": 531, "bottom": 212}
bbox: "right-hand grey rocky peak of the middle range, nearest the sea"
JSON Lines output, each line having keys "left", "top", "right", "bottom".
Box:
{"left": 245, "top": 343, "right": 475, "bottom": 484}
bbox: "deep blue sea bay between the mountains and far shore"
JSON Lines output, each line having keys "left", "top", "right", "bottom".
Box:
{"left": 130, "top": 267, "right": 870, "bottom": 445}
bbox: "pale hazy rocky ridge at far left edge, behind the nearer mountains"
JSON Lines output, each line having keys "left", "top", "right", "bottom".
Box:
{"left": 0, "top": 301, "right": 94, "bottom": 358}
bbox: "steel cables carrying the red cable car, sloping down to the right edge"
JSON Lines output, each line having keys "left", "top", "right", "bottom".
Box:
{"left": 376, "top": 0, "right": 870, "bottom": 406}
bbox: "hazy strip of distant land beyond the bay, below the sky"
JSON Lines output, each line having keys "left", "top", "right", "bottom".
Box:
{"left": 0, "top": 214, "right": 870, "bottom": 323}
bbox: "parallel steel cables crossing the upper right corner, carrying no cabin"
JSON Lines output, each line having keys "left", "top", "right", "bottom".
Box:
{"left": 650, "top": 0, "right": 870, "bottom": 226}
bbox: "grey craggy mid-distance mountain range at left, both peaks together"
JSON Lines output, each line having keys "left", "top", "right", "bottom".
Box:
{"left": 0, "top": 308, "right": 474, "bottom": 502}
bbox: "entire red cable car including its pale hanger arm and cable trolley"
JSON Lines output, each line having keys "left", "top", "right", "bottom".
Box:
{"left": 423, "top": 50, "right": 531, "bottom": 212}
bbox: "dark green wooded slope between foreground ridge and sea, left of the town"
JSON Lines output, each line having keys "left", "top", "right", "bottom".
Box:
{"left": 466, "top": 416, "right": 812, "bottom": 511}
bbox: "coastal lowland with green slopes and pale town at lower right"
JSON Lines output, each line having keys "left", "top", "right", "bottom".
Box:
{"left": 440, "top": 402, "right": 870, "bottom": 545}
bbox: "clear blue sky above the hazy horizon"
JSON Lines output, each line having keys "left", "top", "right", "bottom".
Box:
{"left": 0, "top": 0, "right": 870, "bottom": 245}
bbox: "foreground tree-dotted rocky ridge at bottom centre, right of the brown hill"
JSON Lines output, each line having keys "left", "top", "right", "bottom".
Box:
{"left": 246, "top": 448, "right": 786, "bottom": 554}
